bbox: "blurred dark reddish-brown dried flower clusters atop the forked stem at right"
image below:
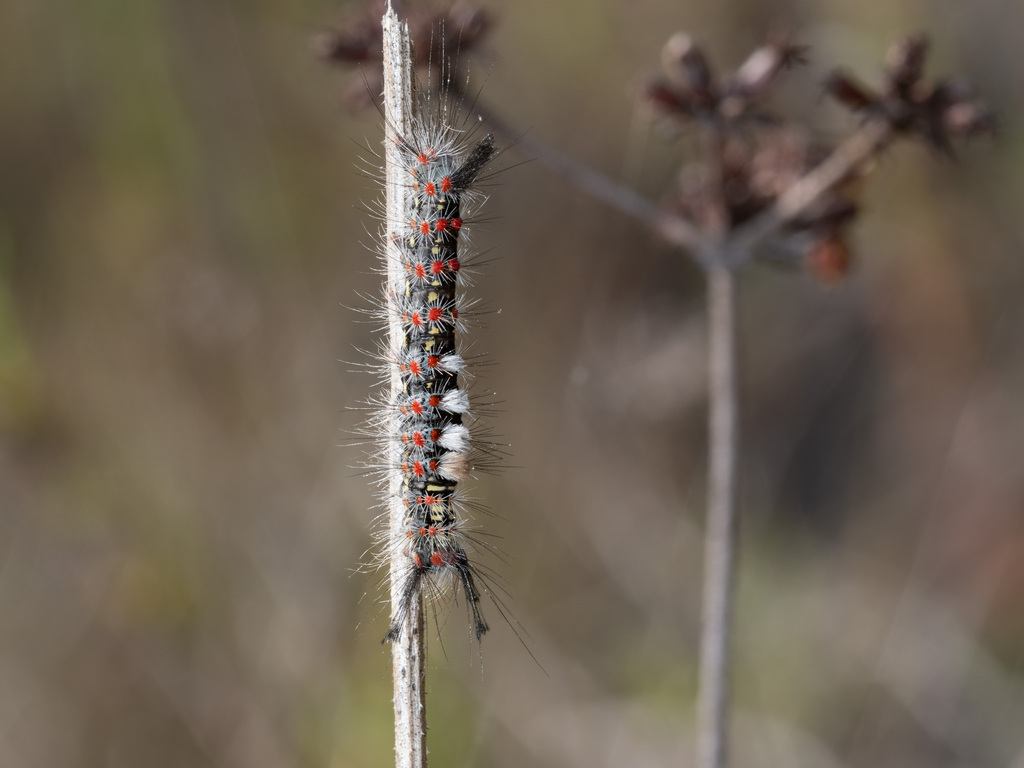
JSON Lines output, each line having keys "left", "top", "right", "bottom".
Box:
{"left": 642, "top": 34, "right": 992, "bottom": 283}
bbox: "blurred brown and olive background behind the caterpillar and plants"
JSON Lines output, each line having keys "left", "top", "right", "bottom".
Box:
{"left": 0, "top": 0, "right": 1024, "bottom": 768}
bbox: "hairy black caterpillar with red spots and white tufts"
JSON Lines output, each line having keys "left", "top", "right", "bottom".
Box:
{"left": 366, "top": 39, "right": 504, "bottom": 642}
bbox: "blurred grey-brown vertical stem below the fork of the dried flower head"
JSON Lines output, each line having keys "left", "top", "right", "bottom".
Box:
{"left": 697, "top": 265, "right": 739, "bottom": 768}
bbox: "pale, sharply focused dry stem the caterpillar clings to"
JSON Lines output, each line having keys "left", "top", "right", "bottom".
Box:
{"left": 383, "top": 2, "right": 427, "bottom": 768}
